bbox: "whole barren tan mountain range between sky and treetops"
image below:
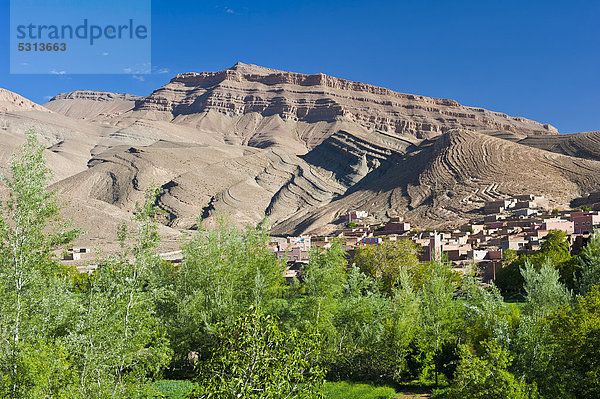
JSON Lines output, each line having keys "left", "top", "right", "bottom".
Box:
{"left": 0, "top": 63, "right": 600, "bottom": 250}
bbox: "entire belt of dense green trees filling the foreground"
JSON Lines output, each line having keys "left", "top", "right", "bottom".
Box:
{"left": 0, "top": 131, "right": 600, "bottom": 398}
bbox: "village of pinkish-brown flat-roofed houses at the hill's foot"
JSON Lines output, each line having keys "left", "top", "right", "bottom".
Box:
{"left": 271, "top": 191, "right": 600, "bottom": 282}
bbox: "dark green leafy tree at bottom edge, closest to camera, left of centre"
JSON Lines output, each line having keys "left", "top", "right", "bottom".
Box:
{"left": 192, "top": 308, "right": 325, "bottom": 399}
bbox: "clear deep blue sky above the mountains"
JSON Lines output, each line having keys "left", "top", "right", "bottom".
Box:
{"left": 0, "top": 0, "right": 600, "bottom": 133}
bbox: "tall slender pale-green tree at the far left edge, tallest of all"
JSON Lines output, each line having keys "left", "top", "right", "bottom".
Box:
{"left": 0, "top": 129, "right": 79, "bottom": 398}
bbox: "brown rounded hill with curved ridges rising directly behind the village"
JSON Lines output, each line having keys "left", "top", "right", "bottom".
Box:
{"left": 275, "top": 130, "right": 600, "bottom": 233}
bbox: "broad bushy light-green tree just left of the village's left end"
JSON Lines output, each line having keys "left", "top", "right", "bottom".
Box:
{"left": 165, "top": 218, "right": 284, "bottom": 363}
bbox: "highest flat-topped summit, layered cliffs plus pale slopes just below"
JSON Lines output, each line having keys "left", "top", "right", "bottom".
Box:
{"left": 122, "top": 63, "right": 557, "bottom": 153}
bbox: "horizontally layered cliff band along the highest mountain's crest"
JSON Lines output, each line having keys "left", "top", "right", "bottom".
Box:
{"left": 134, "top": 63, "right": 557, "bottom": 138}
